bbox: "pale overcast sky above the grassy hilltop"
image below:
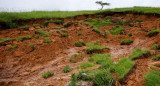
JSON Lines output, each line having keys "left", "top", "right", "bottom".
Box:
{"left": 0, "top": 0, "right": 160, "bottom": 12}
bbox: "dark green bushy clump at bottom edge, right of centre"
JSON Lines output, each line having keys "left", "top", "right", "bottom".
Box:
{"left": 93, "top": 70, "right": 114, "bottom": 86}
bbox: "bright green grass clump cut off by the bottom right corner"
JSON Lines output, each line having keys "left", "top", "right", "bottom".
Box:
{"left": 145, "top": 70, "right": 160, "bottom": 86}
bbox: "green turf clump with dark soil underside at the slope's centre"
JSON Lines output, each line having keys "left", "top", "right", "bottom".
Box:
{"left": 86, "top": 42, "right": 109, "bottom": 53}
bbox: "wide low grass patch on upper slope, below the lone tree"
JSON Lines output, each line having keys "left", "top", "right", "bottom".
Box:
{"left": 82, "top": 18, "right": 112, "bottom": 27}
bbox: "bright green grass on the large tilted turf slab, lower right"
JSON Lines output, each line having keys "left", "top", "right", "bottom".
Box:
{"left": 114, "top": 58, "right": 135, "bottom": 80}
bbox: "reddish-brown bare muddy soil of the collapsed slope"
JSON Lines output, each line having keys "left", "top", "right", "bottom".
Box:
{"left": 0, "top": 13, "right": 160, "bottom": 86}
